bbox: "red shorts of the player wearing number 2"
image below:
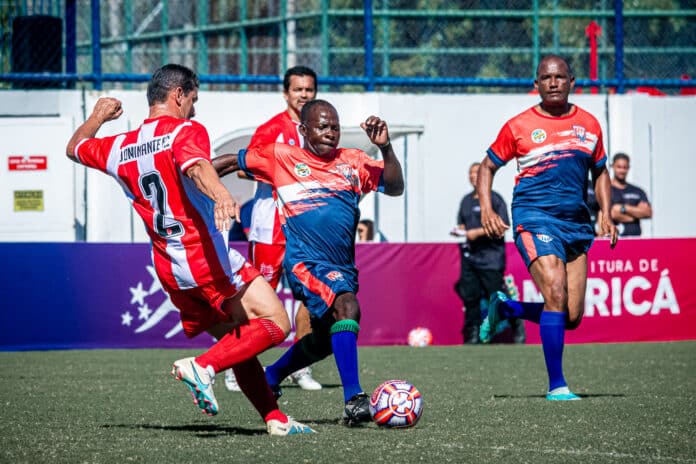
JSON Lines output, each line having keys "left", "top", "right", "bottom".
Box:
{"left": 169, "top": 262, "right": 259, "bottom": 338}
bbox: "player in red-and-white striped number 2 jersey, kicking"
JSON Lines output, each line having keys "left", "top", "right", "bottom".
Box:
{"left": 66, "top": 64, "right": 313, "bottom": 435}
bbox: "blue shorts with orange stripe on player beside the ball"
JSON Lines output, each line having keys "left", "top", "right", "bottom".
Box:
{"left": 285, "top": 262, "right": 358, "bottom": 318}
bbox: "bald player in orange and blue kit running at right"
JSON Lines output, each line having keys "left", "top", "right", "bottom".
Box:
{"left": 477, "top": 55, "right": 617, "bottom": 400}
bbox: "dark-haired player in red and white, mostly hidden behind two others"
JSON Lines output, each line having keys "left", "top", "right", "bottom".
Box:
{"left": 225, "top": 66, "right": 321, "bottom": 391}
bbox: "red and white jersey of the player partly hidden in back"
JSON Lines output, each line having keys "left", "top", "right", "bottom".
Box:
{"left": 248, "top": 111, "right": 303, "bottom": 245}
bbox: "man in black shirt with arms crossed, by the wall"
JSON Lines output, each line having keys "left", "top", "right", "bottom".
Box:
{"left": 611, "top": 153, "right": 652, "bottom": 237}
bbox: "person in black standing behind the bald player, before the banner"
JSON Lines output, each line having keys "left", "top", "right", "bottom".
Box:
{"left": 450, "top": 163, "right": 524, "bottom": 344}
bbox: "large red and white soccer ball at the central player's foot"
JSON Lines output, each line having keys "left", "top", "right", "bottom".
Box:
{"left": 370, "top": 380, "right": 423, "bottom": 428}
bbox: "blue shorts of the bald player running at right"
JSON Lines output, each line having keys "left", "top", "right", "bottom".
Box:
{"left": 515, "top": 219, "right": 594, "bottom": 268}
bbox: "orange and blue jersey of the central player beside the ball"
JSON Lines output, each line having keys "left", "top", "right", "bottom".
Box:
{"left": 239, "top": 143, "right": 384, "bottom": 269}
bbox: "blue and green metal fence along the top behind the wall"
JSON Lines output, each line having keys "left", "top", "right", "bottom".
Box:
{"left": 0, "top": 0, "right": 696, "bottom": 93}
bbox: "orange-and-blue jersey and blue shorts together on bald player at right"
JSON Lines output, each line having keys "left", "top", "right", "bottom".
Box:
{"left": 487, "top": 106, "right": 607, "bottom": 266}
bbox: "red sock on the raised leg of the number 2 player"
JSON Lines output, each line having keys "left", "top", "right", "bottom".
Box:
{"left": 196, "top": 318, "right": 285, "bottom": 379}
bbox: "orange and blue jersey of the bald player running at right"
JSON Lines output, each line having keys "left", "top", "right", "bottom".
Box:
{"left": 487, "top": 105, "right": 607, "bottom": 230}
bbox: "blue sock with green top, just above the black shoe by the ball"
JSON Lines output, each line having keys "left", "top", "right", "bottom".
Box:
{"left": 331, "top": 319, "right": 363, "bottom": 401}
